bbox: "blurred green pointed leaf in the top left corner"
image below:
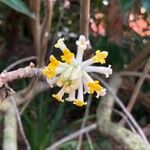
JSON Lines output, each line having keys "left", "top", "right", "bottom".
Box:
{"left": 0, "top": 0, "right": 35, "bottom": 18}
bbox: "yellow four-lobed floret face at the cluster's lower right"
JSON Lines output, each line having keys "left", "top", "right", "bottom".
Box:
{"left": 87, "top": 80, "right": 103, "bottom": 94}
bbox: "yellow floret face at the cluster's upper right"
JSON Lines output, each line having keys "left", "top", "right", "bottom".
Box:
{"left": 93, "top": 50, "right": 108, "bottom": 64}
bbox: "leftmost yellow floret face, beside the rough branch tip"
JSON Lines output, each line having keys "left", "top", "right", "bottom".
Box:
{"left": 42, "top": 67, "right": 56, "bottom": 79}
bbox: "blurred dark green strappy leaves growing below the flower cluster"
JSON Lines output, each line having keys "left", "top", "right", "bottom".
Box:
{"left": 23, "top": 93, "right": 64, "bottom": 150}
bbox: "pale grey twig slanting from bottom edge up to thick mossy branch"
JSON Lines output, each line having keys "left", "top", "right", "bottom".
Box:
{"left": 46, "top": 123, "right": 97, "bottom": 150}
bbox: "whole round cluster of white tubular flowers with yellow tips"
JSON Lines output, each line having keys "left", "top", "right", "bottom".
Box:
{"left": 42, "top": 35, "right": 112, "bottom": 107}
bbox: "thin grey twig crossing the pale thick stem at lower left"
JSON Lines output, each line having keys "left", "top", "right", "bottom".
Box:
{"left": 10, "top": 96, "right": 31, "bottom": 150}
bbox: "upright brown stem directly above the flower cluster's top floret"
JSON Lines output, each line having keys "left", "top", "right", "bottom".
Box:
{"left": 80, "top": 0, "right": 90, "bottom": 38}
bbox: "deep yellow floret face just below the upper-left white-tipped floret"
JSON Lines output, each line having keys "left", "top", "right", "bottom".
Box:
{"left": 61, "top": 48, "right": 74, "bottom": 64}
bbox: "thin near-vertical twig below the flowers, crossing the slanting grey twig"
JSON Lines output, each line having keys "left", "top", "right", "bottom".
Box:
{"left": 77, "top": 95, "right": 92, "bottom": 150}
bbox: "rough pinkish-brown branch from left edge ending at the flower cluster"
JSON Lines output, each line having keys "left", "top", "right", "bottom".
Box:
{"left": 0, "top": 66, "right": 42, "bottom": 87}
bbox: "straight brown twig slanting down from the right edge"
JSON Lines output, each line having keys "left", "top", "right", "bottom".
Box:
{"left": 121, "top": 58, "right": 150, "bottom": 124}
